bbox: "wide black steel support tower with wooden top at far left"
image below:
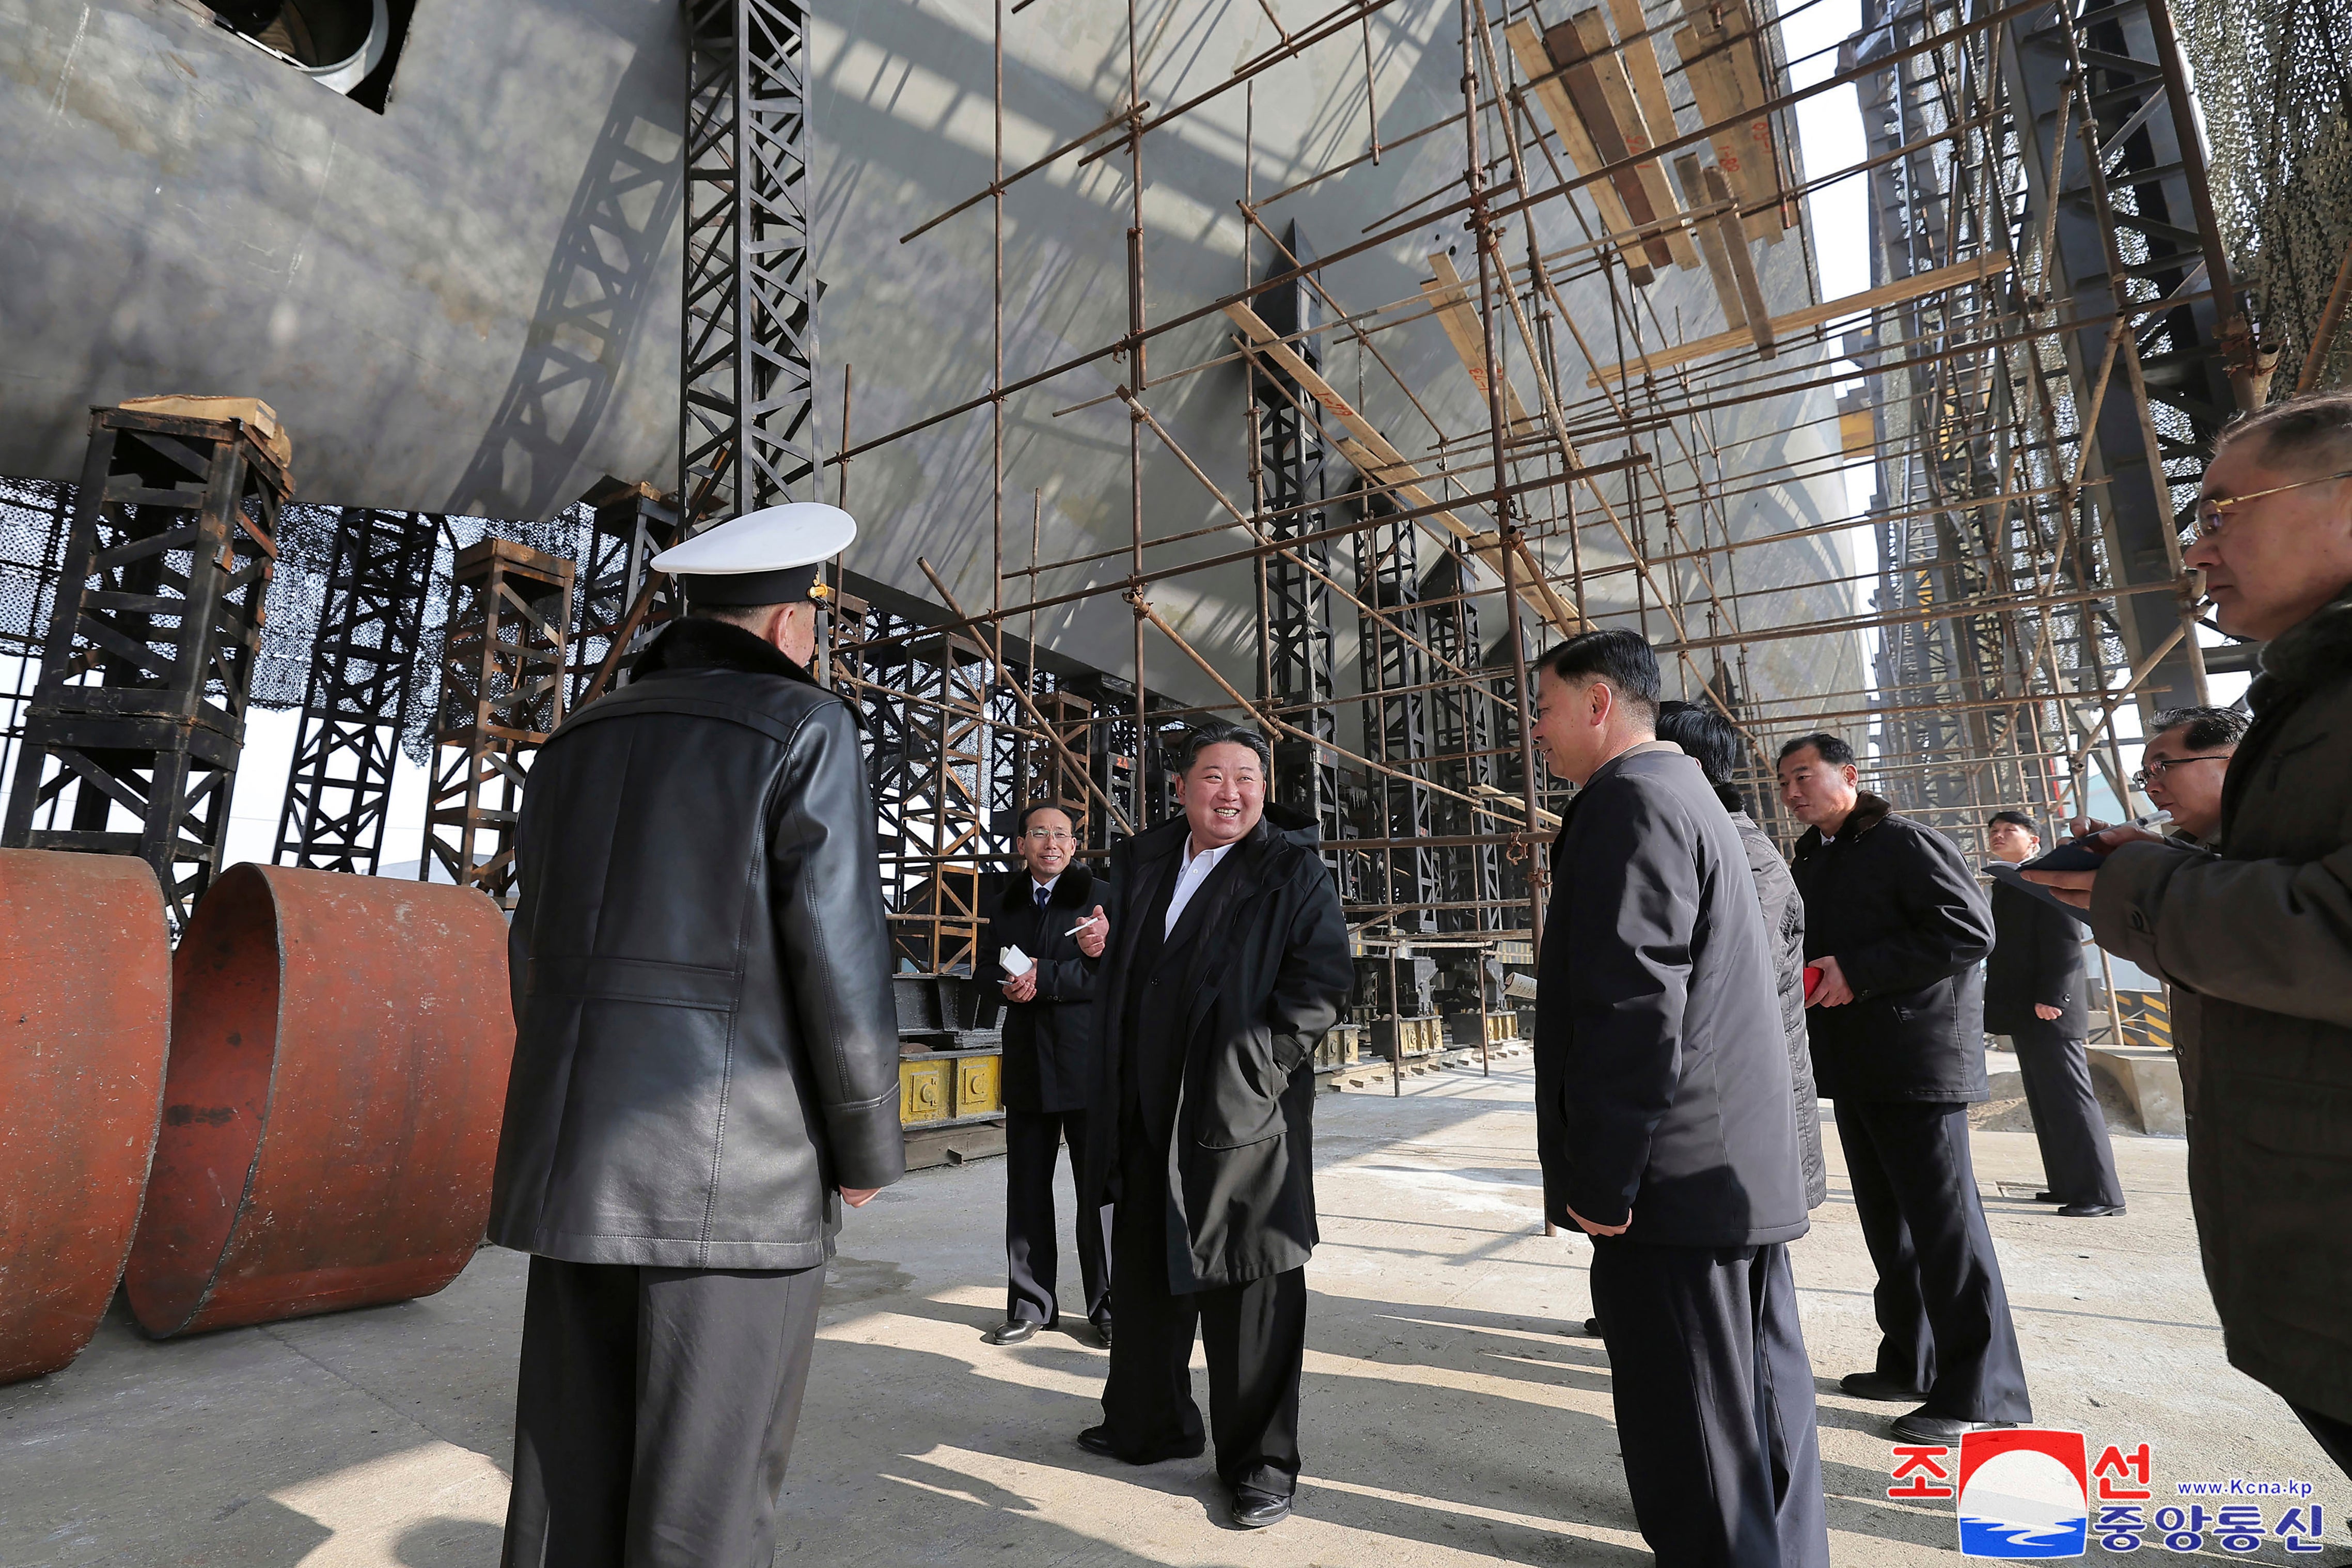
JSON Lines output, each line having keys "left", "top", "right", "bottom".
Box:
{"left": 0, "top": 409, "right": 292, "bottom": 926}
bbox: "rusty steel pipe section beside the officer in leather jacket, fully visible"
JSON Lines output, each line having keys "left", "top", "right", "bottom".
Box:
{"left": 122, "top": 865, "right": 515, "bottom": 1338}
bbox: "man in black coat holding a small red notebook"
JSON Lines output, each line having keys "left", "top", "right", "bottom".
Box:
{"left": 1780, "top": 733, "right": 2032, "bottom": 1444}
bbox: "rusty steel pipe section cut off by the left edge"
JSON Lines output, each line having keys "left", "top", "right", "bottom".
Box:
{"left": 0, "top": 849, "right": 171, "bottom": 1382}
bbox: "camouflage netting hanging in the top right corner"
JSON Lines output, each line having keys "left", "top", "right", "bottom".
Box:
{"left": 2175, "top": 0, "right": 2352, "bottom": 397}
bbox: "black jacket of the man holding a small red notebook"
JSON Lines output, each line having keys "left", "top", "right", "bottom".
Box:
{"left": 1790, "top": 792, "right": 1992, "bottom": 1103}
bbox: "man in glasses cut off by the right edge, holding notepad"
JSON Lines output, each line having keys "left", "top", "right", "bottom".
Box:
{"left": 2028, "top": 393, "right": 2352, "bottom": 1471}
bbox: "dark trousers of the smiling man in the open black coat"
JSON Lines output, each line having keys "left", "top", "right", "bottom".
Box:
{"left": 1103, "top": 1114, "right": 1308, "bottom": 1497}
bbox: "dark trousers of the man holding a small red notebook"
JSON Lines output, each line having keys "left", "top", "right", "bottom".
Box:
{"left": 1837, "top": 1100, "right": 2034, "bottom": 1422}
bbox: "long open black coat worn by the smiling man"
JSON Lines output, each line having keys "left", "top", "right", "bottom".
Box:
{"left": 1079, "top": 806, "right": 1355, "bottom": 1291}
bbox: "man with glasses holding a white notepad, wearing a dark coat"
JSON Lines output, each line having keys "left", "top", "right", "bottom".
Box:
{"left": 981, "top": 802, "right": 1110, "bottom": 1345}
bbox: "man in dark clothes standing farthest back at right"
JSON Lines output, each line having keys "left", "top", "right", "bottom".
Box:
{"left": 1985, "top": 811, "right": 2124, "bottom": 1220}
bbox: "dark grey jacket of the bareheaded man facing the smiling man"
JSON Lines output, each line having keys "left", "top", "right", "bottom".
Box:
{"left": 1536, "top": 741, "right": 1809, "bottom": 1246}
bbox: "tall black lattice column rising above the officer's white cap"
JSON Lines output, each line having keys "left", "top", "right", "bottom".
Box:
{"left": 678, "top": 0, "right": 819, "bottom": 522}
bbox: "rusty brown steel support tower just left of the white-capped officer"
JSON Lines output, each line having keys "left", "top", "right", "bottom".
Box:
{"left": 416, "top": 538, "right": 576, "bottom": 907}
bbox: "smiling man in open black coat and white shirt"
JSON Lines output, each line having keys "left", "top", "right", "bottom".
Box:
{"left": 1077, "top": 724, "right": 1355, "bottom": 1528}
